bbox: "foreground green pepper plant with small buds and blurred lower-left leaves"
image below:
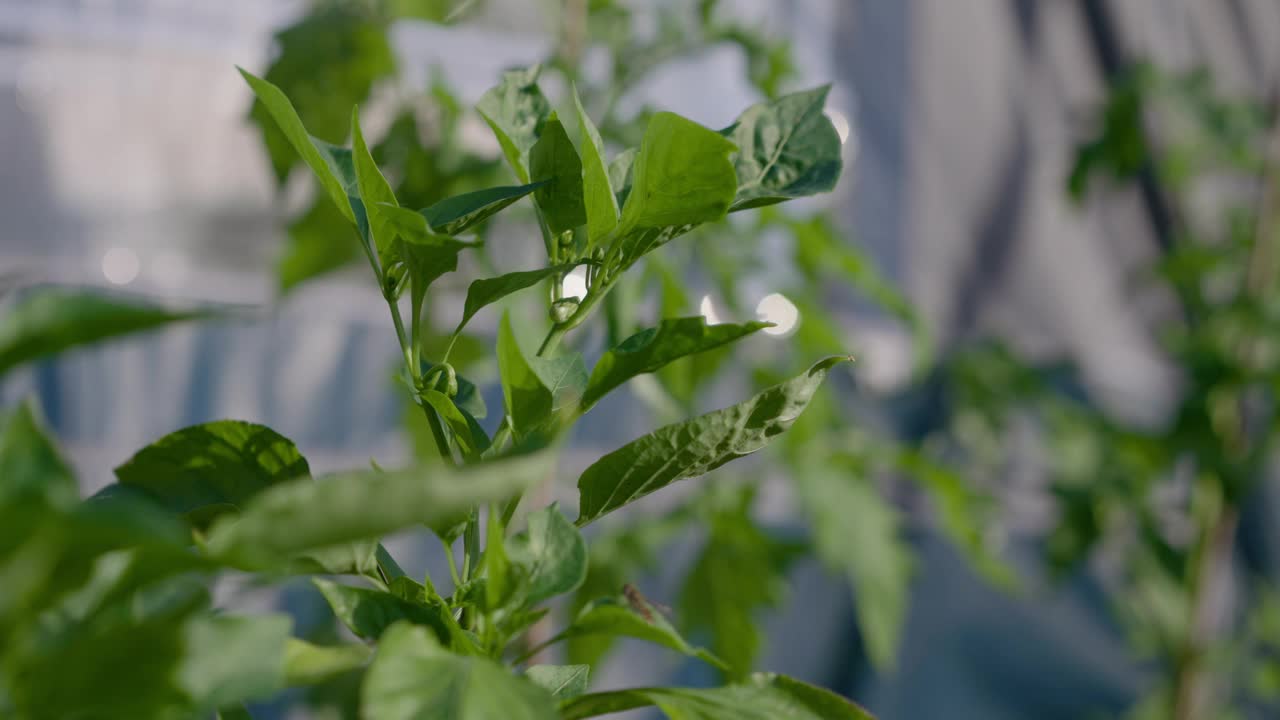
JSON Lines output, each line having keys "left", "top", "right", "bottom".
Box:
{"left": 0, "top": 57, "right": 867, "bottom": 720}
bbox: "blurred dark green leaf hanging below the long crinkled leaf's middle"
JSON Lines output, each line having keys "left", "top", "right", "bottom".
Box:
{"left": 678, "top": 487, "right": 800, "bottom": 679}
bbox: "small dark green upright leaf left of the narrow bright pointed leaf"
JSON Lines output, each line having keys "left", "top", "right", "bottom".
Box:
{"left": 529, "top": 113, "right": 586, "bottom": 233}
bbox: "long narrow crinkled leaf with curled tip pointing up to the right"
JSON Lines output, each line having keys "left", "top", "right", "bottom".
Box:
{"left": 577, "top": 356, "right": 849, "bottom": 527}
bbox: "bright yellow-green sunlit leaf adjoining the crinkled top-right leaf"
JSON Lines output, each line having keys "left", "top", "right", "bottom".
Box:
{"left": 620, "top": 113, "right": 737, "bottom": 232}
